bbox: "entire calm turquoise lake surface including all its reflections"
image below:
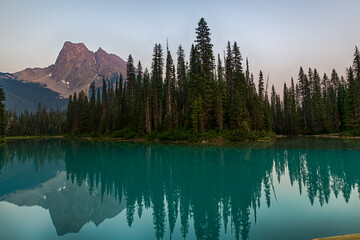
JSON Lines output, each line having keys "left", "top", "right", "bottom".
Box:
{"left": 0, "top": 138, "right": 360, "bottom": 240}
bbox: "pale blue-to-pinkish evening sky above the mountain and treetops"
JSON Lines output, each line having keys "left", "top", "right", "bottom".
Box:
{"left": 0, "top": 0, "right": 360, "bottom": 90}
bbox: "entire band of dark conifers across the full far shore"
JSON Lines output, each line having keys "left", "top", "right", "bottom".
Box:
{"left": 0, "top": 18, "right": 360, "bottom": 141}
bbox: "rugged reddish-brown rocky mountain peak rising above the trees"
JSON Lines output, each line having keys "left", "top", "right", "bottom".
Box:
{"left": 14, "top": 42, "right": 126, "bottom": 97}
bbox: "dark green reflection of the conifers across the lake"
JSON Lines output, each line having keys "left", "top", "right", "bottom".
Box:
{"left": 0, "top": 138, "right": 360, "bottom": 239}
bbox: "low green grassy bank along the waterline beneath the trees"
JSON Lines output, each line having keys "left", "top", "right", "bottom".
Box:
{"left": 4, "top": 128, "right": 360, "bottom": 145}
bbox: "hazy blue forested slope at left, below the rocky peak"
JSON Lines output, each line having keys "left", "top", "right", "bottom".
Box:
{"left": 0, "top": 73, "right": 68, "bottom": 113}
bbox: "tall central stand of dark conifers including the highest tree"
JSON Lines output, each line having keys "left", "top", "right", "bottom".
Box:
{"left": 62, "top": 18, "right": 271, "bottom": 138}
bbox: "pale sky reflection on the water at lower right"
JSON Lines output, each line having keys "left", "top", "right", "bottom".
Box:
{"left": 250, "top": 169, "right": 360, "bottom": 239}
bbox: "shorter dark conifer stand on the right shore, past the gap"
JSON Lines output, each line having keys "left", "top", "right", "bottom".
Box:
{"left": 270, "top": 47, "right": 360, "bottom": 135}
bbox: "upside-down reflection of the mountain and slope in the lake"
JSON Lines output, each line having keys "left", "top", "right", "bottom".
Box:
{"left": 0, "top": 161, "right": 126, "bottom": 236}
